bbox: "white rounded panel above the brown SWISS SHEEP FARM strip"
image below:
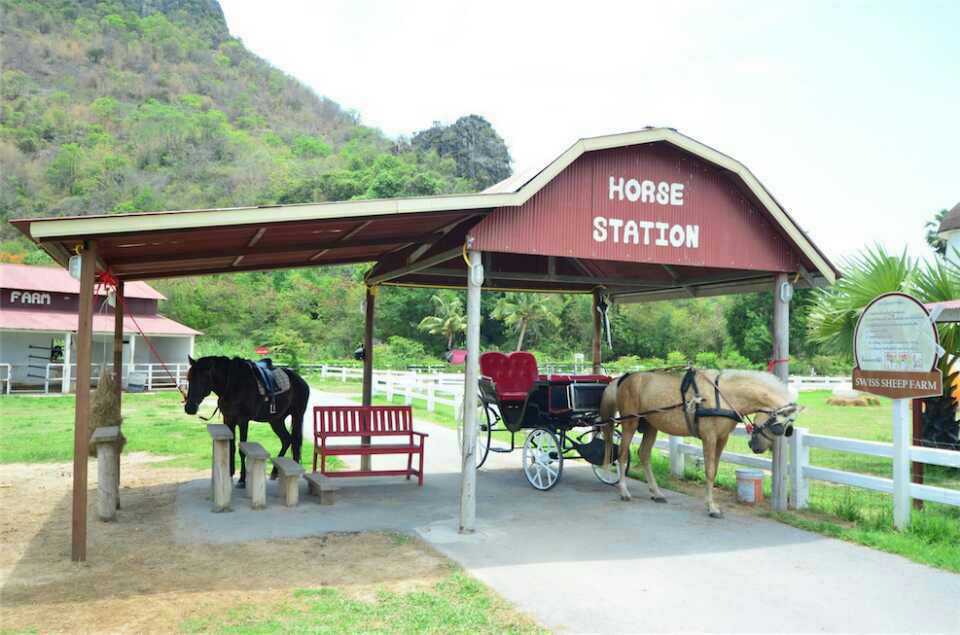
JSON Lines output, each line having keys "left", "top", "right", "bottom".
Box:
{"left": 853, "top": 293, "right": 938, "bottom": 373}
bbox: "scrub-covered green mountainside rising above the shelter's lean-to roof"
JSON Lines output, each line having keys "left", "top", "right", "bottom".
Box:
{"left": 0, "top": 0, "right": 509, "bottom": 248}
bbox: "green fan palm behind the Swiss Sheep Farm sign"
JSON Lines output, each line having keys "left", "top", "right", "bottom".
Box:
{"left": 808, "top": 246, "right": 960, "bottom": 447}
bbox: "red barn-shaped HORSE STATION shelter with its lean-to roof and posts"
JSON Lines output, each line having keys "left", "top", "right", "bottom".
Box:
{"left": 7, "top": 128, "right": 838, "bottom": 559}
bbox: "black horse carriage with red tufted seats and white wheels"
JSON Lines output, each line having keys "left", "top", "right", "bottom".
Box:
{"left": 464, "top": 352, "right": 632, "bottom": 491}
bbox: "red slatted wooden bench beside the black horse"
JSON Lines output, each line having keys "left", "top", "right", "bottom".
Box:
{"left": 313, "top": 406, "right": 428, "bottom": 486}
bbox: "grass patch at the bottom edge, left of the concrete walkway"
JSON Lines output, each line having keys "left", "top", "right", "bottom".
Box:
{"left": 182, "top": 572, "right": 545, "bottom": 635}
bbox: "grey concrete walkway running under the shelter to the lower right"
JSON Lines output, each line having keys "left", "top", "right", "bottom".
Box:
{"left": 176, "top": 394, "right": 960, "bottom": 633}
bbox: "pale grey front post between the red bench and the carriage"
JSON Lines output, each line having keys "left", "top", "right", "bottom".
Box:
{"left": 460, "top": 251, "right": 483, "bottom": 534}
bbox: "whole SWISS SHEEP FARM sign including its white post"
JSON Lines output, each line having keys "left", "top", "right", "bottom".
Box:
{"left": 853, "top": 293, "right": 943, "bottom": 529}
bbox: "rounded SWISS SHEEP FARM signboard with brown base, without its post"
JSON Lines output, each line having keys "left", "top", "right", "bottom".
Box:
{"left": 853, "top": 293, "right": 943, "bottom": 399}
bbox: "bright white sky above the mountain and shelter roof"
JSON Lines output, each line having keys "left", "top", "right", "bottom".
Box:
{"left": 221, "top": 0, "right": 960, "bottom": 263}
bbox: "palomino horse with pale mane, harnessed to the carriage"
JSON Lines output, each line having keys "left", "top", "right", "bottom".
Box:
{"left": 600, "top": 369, "right": 800, "bottom": 518}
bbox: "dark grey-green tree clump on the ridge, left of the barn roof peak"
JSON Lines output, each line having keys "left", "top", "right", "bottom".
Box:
{"left": 411, "top": 115, "right": 511, "bottom": 189}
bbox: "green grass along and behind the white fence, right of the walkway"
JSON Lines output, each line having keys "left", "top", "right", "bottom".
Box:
{"left": 318, "top": 381, "right": 960, "bottom": 573}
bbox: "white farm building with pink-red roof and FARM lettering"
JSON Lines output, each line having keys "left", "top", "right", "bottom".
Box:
{"left": 0, "top": 264, "right": 199, "bottom": 393}
